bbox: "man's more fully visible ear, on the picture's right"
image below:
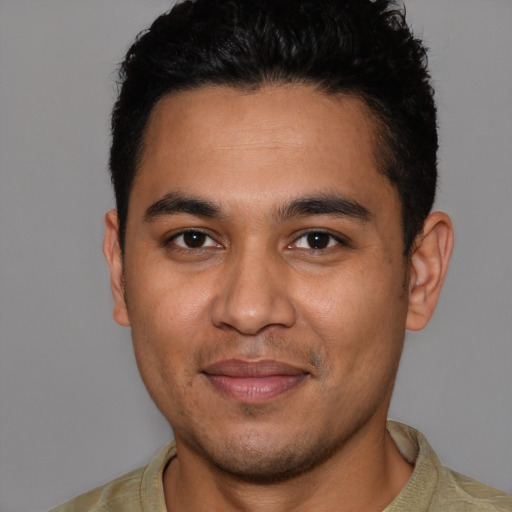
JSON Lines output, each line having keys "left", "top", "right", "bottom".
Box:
{"left": 406, "top": 212, "right": 453, "bottom": 331}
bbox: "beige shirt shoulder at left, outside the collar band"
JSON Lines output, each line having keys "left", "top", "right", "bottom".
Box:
{"left": 51, "top": 468, "right": 146, "bottom": 512}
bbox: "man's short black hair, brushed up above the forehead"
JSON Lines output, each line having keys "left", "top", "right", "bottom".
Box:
{"left": 110, "top": 0, "right": 438, "bottom": 254}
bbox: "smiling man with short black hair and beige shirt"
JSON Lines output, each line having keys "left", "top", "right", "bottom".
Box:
{"left": 51, "top": 0, "right": 512, "bottom": 512}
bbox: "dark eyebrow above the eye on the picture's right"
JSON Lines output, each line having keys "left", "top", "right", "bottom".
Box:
{"left": 276, "top": 194, "right": 371, "bottom": 222}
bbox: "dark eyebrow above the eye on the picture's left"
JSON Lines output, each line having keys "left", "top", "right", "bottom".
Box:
{"left": 144, "top": 192, "right": 222, "bottom": 222}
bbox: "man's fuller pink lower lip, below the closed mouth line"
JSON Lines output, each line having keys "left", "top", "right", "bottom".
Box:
{"left": 205, "top": 374, "right": 306, "bottom": 404}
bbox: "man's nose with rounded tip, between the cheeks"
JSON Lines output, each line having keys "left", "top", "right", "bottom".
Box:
{"left": 211, "top": 251, "right": 296, "bottom": 335}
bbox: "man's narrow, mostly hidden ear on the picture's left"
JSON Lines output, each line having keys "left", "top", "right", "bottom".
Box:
{"left": 103, "top": 210, "right": 130, "bottom": 326}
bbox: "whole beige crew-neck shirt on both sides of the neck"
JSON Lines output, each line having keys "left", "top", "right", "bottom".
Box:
{"left": 51, "top": 421, "right": 512, "bottom": 512}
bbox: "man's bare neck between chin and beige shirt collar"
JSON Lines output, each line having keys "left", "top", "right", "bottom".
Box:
{"left": 164, "top": 423, "right": 413, "bottom": 512}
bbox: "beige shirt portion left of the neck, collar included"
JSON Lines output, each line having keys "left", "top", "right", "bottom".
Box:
{"left": 50, "top": 442, "right": 176, "bottom": 512}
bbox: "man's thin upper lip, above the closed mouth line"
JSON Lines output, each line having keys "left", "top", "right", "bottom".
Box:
{"left": 203, "top": 359, "right": 309, "bottom": 378}
